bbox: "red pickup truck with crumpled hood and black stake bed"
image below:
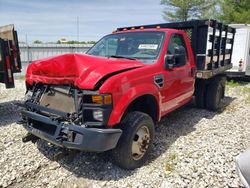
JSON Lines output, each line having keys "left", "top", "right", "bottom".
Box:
{"left": 22, "top": 20, "right": 235, "bottom": 169}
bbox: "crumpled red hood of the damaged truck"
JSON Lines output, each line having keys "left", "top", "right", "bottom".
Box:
{"left": 26, "top": 54, "right": 144, "bottom": 89}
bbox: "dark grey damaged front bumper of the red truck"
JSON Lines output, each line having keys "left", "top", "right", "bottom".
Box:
{"left": 21, "top": 110, "right": 122, "bottom": 152}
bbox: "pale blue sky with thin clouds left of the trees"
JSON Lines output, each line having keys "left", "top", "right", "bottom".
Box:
{"left": 0, "top": 0, "right": 164, "bottom": 43}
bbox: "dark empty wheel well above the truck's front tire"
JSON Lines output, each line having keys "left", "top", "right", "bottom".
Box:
{"left": 125, "top": 95, "right": 159, "bottom": 123}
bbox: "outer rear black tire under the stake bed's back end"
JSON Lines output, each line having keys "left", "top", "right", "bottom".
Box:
{"left": 206, "top": 77, "right": 225, "bottom": 111}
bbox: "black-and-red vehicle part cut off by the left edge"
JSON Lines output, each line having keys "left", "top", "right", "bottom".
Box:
{"left": 0, "top": 24, "right": 22, "bottom": 88}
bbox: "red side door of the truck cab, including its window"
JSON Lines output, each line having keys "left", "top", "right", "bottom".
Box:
{"left": 162, "top": 33, "right": 194, "bottom": 114}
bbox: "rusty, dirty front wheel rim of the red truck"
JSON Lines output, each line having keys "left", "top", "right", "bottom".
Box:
{"left": 132, "top": 125, "right": 150, "bottom": 160}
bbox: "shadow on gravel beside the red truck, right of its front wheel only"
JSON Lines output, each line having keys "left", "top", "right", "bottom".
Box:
{"left": 149, "top": 96, "right": 235, "bottom": 162}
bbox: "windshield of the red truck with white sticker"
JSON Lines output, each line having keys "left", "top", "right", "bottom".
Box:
{"left": 87, "top": 31, "right": 164, "bottom": 64}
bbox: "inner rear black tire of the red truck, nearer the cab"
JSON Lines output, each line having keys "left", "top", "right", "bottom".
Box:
{"left": 195, "top": 80, "right": 206, "bottom": 108}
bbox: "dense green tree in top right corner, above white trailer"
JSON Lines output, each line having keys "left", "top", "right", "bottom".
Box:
{"left": 219, "top": 0, "right": 250, "bottom": 23}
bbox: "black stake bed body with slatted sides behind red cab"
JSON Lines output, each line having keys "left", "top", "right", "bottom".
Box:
{"left": 117, "top": 20, "right": 236, "bottom": 79}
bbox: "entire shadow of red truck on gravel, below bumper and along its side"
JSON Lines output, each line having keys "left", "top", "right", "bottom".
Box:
{"left": 37, "top": 97, "right": 234, "bottom": 181}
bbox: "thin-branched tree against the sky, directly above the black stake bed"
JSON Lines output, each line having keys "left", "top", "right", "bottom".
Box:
{"left": 161, "top": 0, "right": 218, "bottom": 21}
